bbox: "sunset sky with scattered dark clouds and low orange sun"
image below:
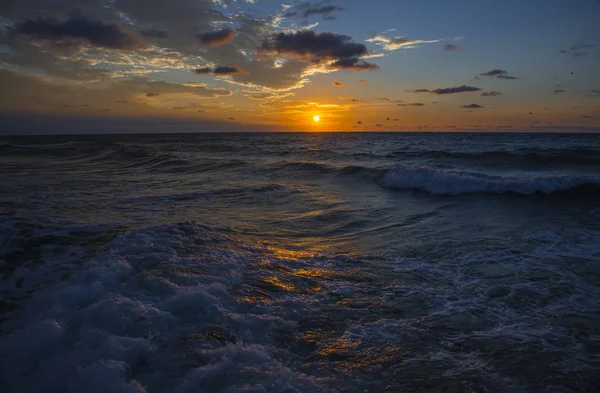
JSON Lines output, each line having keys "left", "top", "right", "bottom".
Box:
{"left": 0, "top": 0, "right": 600, "bottom": 133}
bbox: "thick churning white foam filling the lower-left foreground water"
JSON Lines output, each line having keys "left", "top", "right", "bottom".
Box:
{"left": 0, "top": 224, "right": 326, "bottom": 393}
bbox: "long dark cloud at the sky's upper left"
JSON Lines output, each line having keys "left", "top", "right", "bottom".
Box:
{"left": 17, "top": 14, "right": 143, "bottom": 49}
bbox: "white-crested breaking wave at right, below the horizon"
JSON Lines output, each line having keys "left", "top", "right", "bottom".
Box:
{"left": 380, "top": 165, "right": 600, "bottom": 195}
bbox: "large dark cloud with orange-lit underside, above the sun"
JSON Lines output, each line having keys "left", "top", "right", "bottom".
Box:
{"left": 259, "top": 30, "right": 379, "bottom": 71}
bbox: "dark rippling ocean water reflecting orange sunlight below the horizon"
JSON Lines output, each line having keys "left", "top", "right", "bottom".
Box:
{"left": 0, "top": 133, "right": 600, "bottom": 393}
